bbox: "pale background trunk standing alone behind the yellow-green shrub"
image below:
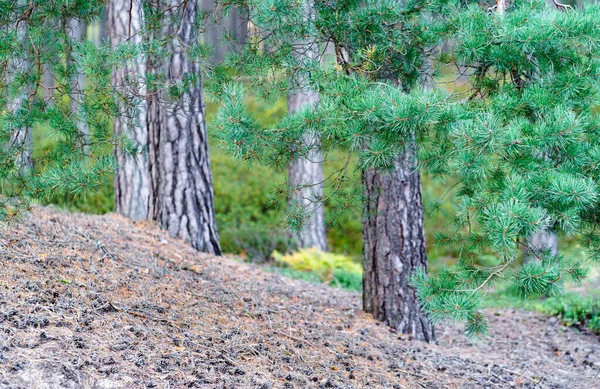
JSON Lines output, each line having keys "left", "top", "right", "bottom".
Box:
{"left": 288, "top": 0, "right": 327, "bottom": 251}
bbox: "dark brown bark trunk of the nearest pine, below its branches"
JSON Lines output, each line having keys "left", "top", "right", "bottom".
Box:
{"left": 362, "top": 144, "right": 434, "bottom": 341}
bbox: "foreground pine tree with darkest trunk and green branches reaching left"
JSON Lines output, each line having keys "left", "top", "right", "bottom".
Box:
{"left": 213, "top": 1, "right": 442, "bottom": 340}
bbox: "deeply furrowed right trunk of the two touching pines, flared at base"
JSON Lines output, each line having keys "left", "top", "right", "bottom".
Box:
{"left": 148, "top": 1, "right": 221, "bottom": 254}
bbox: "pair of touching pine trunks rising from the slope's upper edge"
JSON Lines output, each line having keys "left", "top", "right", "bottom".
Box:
{"left": 109, "top": 1, "right": 221, "bottom": 254}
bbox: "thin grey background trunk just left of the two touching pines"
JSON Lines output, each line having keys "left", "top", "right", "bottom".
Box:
{"left": 66, "top": 19, "right": 90, "bottom": 154}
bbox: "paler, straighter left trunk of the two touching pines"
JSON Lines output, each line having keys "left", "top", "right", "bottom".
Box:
{"left": 107, "top": 0, "right": 151, "bottom": 220}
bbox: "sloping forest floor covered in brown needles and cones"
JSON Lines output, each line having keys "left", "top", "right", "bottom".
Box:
{"left": 0, "top": 208, "right": 600, "bottom": 389}
